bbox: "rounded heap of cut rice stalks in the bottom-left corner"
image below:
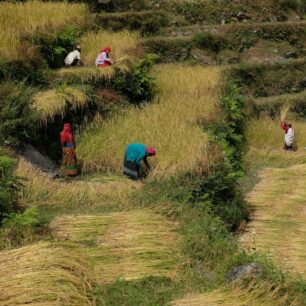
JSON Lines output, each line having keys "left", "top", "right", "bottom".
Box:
{"left": 0, "top": 242, "right": 95, "bottom": 306}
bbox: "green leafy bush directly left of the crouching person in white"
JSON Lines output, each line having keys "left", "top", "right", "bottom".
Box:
{"left": 33, "top": 27, "right": 81, "bottom": 68}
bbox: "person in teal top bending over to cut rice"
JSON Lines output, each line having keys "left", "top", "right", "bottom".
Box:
{"left": 123, "top": 143, "right": 156, "bottom": 180}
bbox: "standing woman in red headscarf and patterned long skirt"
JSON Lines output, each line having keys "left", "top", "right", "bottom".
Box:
{"left": 60, "top": 123, "right": 78, "bottom": 176}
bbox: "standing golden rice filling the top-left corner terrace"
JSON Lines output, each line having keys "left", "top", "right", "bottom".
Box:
{"left": 0, "top": 1, "right": 89, "bottom": 60}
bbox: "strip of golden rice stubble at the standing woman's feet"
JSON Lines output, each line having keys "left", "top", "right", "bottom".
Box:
{"left": 16, "top": 159, "right": 141, "bottom": 207}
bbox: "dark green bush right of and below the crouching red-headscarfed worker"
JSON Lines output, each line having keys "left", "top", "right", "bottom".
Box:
{"left": 112, "top": 54, "right": 157, "bottom": 104}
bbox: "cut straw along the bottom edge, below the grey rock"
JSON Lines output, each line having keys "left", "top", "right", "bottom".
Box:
{"left": 171, "top": 283, "right": 298, "bottom": 306}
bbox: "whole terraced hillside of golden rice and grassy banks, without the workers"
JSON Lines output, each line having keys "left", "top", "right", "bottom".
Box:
{"left": 0, "top": 0, "right": 306, "bottom": 306}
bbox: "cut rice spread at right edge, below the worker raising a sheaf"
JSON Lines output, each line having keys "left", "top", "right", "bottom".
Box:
{"left": 241, "top": 164, "right": 306, "bottom": 276}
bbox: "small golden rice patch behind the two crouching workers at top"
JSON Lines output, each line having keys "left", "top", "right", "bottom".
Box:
{"left": 80, "top": 31, "right": 139, "bottom": 66}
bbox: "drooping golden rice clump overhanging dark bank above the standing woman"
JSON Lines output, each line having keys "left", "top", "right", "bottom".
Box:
{"left": 33, "top": 87, "right": 89, "bottom": 123}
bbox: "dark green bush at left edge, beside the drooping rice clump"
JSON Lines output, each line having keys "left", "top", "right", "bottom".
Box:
{"left": 0, "top": 82, "right": 36, "bottom": 146}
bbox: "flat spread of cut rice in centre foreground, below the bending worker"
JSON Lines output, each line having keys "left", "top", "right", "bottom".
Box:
{"left": 51, "top": 211, "right": 180, "bottom": 283}
